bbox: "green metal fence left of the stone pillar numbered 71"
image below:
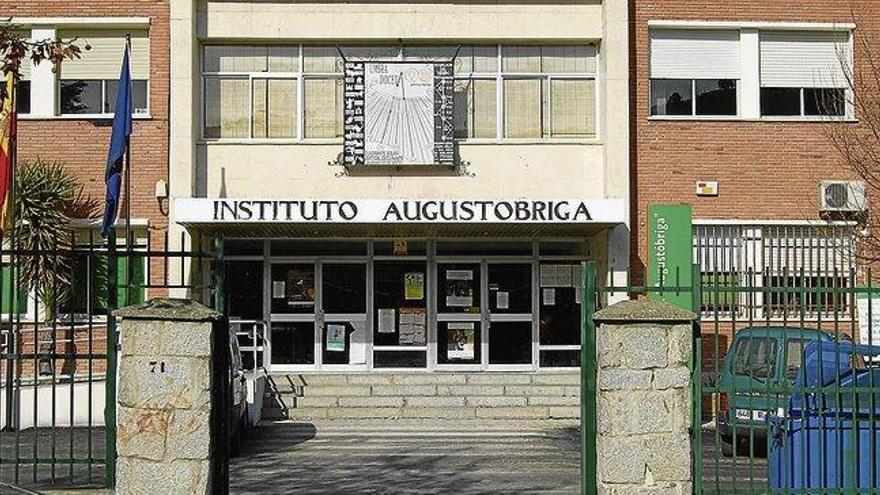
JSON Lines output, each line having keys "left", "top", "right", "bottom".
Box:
{"left": 0, "top": 229, "right": 223, "bottom": 489}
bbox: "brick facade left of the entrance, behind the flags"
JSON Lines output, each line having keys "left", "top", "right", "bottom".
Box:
{"left": 0, "top": 0, "right": 170, "bottom": 286}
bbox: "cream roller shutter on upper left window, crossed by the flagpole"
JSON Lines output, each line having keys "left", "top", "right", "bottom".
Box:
{"left": 58, "top": 29, "right": 150, "bottom": 80}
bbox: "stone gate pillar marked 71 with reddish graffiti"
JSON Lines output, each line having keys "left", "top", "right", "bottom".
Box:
{"left": 114, "top": 299, "right": 228, "bottom": 494}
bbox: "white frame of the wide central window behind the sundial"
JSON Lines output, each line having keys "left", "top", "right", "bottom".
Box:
{"left": 199, "top": 42, "right": 601, "bottom": 144}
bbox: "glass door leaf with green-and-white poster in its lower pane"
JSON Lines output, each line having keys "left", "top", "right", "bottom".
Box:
{"left": 318, "top": 262, "right": 367, "bottom": 370}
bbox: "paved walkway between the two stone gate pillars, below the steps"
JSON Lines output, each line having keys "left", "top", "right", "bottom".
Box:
{"left": 230, "top": 420, "right": 580, "bottom": 494}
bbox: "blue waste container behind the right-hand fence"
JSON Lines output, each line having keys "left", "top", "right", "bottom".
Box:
{"left": 769, "top": 342, "right": 880, "bottom": 490}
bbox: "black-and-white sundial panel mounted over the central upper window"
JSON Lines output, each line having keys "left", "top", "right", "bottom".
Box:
{"left": 343, "top": 61, "right": 455, "bottom": 166}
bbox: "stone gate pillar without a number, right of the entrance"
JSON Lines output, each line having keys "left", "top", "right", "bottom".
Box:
{"left": 594, "top": 301, "right": 696, "bottom": 495}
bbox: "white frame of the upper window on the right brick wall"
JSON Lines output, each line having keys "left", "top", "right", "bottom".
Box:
{"left": 646, "top": 19, "right": 856, "bottom": 122}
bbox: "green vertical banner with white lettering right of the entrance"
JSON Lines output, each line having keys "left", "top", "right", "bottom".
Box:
{"left": 648, "top": 204, "right": 694, "bottom": 310}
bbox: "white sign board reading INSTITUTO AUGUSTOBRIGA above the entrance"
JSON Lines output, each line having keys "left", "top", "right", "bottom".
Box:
{"left": 173, "top": 198, "right": 626, "bottom": 224}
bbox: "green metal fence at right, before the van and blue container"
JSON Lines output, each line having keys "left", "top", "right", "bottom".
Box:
{"left": 582, "top": 262, "right": 880, "bottom": 494}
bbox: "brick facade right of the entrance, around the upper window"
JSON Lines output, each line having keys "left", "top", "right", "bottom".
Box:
{"left": 630, "top": 0, "right": 880, "bottom": 279}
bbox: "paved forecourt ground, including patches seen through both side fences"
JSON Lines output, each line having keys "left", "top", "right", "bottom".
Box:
{"left": 0, "top": 420, "right": 767, "bottom": 494}
